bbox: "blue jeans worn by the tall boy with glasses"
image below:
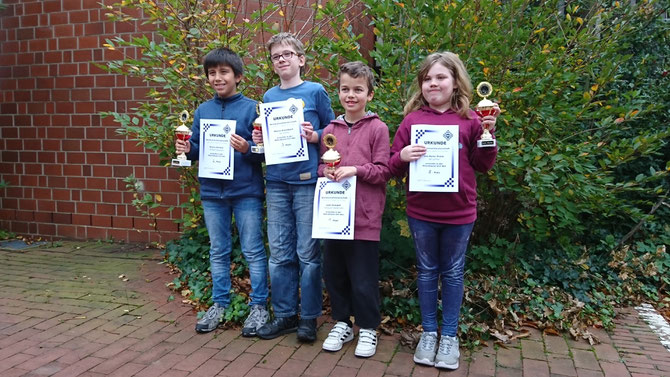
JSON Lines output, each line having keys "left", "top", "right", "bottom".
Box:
{"left": 266, "top": 181, "right": 323, "bottom": 319}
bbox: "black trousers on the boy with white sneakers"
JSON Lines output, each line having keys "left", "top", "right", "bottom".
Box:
{"left": 323, "top": 240, "right": 381, "bottom": 329}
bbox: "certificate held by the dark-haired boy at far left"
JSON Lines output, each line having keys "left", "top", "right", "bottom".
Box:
{"left": 198, "top": 119, "right": 235, "bottom": 180}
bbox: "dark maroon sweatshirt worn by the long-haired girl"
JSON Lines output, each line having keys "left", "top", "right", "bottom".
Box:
{"left": 389, "top": 106, "right": 498, "bottom": 225}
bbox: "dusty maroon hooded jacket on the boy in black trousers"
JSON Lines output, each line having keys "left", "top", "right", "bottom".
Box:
{"left": 318, "top": 113, "right": 391, "bottom": 241}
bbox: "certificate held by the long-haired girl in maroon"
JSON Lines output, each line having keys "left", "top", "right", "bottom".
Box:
{"left": 409, "top": 124, "right": 458, "bottom": 192}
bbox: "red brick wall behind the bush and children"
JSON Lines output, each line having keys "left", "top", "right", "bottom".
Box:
{"left": 0, "top": 0, "right": 371, "bottom": 242}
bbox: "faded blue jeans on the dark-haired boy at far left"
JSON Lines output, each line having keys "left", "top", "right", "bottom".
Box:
{"left": 202, "top": 198, "right": 268, "bottom": 307}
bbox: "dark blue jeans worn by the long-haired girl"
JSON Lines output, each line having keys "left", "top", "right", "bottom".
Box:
{"left": 407, "top": 216, "right": 474, "bottom": 336}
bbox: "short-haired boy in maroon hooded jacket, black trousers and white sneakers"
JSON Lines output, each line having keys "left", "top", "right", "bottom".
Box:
{"left": 318, "top": 62, "right": 390, "bottom": 357}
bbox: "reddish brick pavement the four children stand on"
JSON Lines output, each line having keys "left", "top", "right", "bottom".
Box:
{"left": 0, "top": 242, "right": 670, "bottom": 377}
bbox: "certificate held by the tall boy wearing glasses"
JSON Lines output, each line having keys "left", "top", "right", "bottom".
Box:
{"left": 260, "top": 98, "right": 309, "bottom": 165}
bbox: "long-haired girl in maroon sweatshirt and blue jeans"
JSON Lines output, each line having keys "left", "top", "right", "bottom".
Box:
{"left": 389, "top": 52, "right": 500, "bottom": 369}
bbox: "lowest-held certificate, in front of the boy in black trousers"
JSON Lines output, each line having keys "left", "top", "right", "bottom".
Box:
{"left": 312, "top": 176, "right": 356, "bottom": 240}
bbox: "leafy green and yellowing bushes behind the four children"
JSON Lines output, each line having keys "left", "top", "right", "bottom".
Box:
{"left": 106, "top": 0, "right": 670, "bottom": 342}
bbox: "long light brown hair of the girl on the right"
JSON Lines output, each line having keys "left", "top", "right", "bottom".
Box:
{"left": 404, "top": 51, "right": 472, "bottom": 119}
